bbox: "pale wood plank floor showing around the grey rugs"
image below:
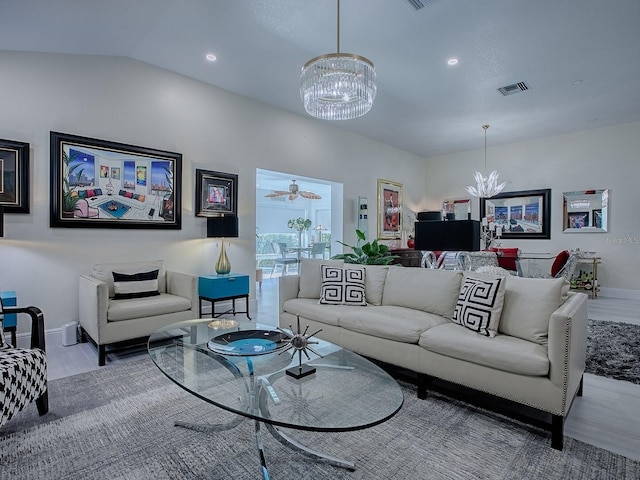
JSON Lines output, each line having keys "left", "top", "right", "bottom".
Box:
{"left": 47, "top": 277, "right": 640, "bottom": 461}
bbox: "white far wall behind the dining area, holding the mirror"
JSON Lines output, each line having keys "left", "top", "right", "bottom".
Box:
{"left": 425, "top": 122, "right": 640, "bottom": 298}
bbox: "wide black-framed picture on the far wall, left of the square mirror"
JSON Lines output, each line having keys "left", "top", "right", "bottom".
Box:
{"left": 480, "top": 188, "right": 551, "bottom": 240}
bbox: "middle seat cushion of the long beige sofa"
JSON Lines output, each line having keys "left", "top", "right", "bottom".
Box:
{"left": 338, "top": 306, "right": 450, "bottom": 344}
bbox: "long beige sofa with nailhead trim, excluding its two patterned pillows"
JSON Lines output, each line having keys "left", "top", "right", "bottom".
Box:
{"left": 279, "top": 259, "right": 587, "bottom": 450}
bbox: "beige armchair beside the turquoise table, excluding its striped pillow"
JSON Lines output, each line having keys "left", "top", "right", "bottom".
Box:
{"left": 78, "top": 260, "right": 198, "bottom": 366}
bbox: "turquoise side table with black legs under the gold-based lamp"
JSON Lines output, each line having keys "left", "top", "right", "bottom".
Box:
{"left": 198, "top": 273, "right": 251, "bottom": 320}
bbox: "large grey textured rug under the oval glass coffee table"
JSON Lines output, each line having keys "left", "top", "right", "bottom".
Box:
{"left": 0, "top": 359, "right": 640, "bottom": 480}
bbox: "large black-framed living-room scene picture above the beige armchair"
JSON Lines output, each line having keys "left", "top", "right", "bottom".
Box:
{"left": 49, "top": 132, "right": 182, "bottom": 230}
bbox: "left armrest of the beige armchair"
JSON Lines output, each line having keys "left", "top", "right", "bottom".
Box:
{"left": 78, "top": 275, "right": 109, "bottom": 344}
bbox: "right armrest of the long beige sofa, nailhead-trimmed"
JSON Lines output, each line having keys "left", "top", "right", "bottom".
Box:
{"left": 548, "top": 292, "right": 587, "bottom": 409}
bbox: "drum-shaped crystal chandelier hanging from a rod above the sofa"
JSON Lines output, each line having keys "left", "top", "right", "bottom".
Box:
{"left": 300, "top": 0, "right": 376, "bottom": 120}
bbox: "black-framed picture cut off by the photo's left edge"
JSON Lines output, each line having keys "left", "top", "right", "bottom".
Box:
{"left": 0, "top": 140, "right": 29, "bottom": 213}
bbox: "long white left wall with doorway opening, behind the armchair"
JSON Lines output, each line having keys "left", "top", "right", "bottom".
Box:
{"left": 0, "top": 52, "right": 425, "bottom": 329}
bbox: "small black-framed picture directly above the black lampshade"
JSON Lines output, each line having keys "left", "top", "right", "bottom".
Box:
{"left": 196, "top": 169, "right": 238, "bottom": 217}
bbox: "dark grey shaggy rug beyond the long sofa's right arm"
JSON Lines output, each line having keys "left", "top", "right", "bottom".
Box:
{"left": 585, "top": 320, "right": 640, "bottom": 384}
